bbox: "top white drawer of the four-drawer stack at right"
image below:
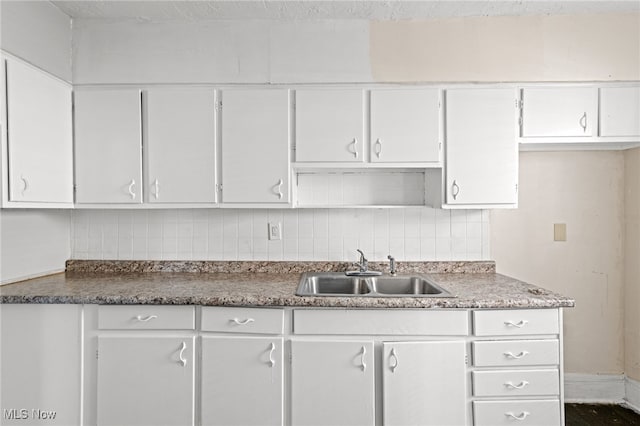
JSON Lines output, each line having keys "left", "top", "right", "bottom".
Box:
{"left": 473, "top": 309, "right": 560, "bottom": 336}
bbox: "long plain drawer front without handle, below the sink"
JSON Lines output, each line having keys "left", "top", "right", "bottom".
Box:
{"left": 293, "top": 309, "right": 469, "bottom": 336}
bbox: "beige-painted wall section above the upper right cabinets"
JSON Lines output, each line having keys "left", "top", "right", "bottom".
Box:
{"left": 370, "top": 14, "right": 640, "bottom": 82}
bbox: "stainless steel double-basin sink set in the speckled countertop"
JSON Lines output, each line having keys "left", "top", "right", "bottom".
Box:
{"left": 296, "top": 272, "right": 455, "bottom": 297}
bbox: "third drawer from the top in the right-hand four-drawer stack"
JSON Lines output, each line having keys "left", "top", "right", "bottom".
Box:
{"left": 473, "top": 369, "right": 560, "bottom": 397}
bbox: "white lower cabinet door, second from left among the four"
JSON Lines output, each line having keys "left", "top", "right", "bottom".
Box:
{"left": 201, "top": 337, "right": 284, "bottom": 426}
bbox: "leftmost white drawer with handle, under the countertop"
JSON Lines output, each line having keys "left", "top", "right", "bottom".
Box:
{"left": 98, "top": 305, "right": 195, "bottom": 330}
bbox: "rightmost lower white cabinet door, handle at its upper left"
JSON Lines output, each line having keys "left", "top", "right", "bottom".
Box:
{"left": 382, "top": 341, "right": 467, "bottom": 426}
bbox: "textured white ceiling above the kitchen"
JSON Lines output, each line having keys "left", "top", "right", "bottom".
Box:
{"left": 52, "top": 0, "right": 640, "bottom": 21}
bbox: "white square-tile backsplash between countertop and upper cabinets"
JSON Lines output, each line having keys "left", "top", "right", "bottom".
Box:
{"left": 71, "top": 207, "right": 490, "bottom": 261}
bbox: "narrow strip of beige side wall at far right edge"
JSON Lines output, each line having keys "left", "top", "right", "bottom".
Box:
{"left": 624, "top": 148, "right": 640, "bottom": 380}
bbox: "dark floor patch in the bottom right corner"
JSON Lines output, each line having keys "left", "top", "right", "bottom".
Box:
{"left": 564, "top": 404, "right": 640, "bottom": 426}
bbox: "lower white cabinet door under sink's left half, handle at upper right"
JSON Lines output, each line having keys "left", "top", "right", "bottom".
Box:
{"left": 291, "top": 340, "right": 375, "bottom": 426}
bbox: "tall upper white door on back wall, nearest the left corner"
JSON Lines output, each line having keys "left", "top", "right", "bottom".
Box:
{"left": 74, "top": 89, "right": 142, "bottom": 204}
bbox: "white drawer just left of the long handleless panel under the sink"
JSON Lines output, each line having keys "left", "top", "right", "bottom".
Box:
{"left": 201, "top": 307, "right": 284, "bottom": 334}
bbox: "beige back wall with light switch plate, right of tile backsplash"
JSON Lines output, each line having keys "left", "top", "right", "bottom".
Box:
{"left": 490, "top": 151, "right": 624, "bottom": 374}
